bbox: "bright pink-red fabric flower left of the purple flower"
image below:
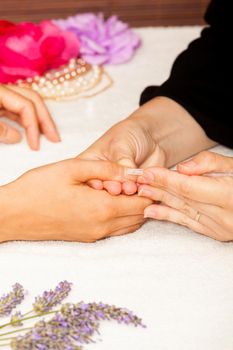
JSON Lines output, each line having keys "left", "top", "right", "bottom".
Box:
{"left": 0, "top": 21, "right": 79, "bottom": 83}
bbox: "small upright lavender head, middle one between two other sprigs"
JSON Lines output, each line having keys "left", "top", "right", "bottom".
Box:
{"left": 33, "top": 281, "right": 72, "bottom": 314}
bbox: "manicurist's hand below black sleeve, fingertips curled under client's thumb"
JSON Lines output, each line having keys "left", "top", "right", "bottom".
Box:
{"left": 79, "top": 97, "right": 214, "bottom": 194}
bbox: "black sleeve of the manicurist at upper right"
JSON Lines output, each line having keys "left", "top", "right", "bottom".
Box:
{"left": 140, "top": 0, "right": 233, "bottom": 148}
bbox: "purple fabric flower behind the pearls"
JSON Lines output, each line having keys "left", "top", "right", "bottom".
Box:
{"left": 54, "top": 13, "right": 140, "bottom": 64}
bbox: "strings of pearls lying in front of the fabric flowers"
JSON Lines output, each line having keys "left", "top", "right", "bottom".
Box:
{"left": 17, "top": 58, "right": 103, "bottom": 100}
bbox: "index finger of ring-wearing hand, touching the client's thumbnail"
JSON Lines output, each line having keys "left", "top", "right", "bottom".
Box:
{"left": 137, "top": 167, "right": 230, "bottom": 207}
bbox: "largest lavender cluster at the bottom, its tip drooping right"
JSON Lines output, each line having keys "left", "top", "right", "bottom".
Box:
{"left": 11, "top": 302, "right": 144, "bottom": 350}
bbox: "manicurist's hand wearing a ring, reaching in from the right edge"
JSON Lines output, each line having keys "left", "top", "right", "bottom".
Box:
{"left": 138, "top": 152, "right": 233, "bottom": 241}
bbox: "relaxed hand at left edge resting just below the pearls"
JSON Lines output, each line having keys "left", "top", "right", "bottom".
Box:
{"left": 0, "top": 84, "right": 60, "bottom": 150}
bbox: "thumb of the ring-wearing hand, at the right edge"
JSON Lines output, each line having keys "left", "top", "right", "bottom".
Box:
{"left": 177, "top": 151, "right": 233, "bottom": 175}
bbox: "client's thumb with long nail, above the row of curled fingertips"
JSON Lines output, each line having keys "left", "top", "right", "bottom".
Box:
{"left": 68, "top": 158, "right": 136, "bottom": 182}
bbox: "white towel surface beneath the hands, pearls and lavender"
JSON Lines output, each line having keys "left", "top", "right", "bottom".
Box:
{"left": 0, "top": 27, "right": 233, "bottom": 350}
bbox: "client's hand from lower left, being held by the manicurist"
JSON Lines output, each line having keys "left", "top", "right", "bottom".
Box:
{"left": 0, "top": 159, "right": 152, "bottom": 242}
